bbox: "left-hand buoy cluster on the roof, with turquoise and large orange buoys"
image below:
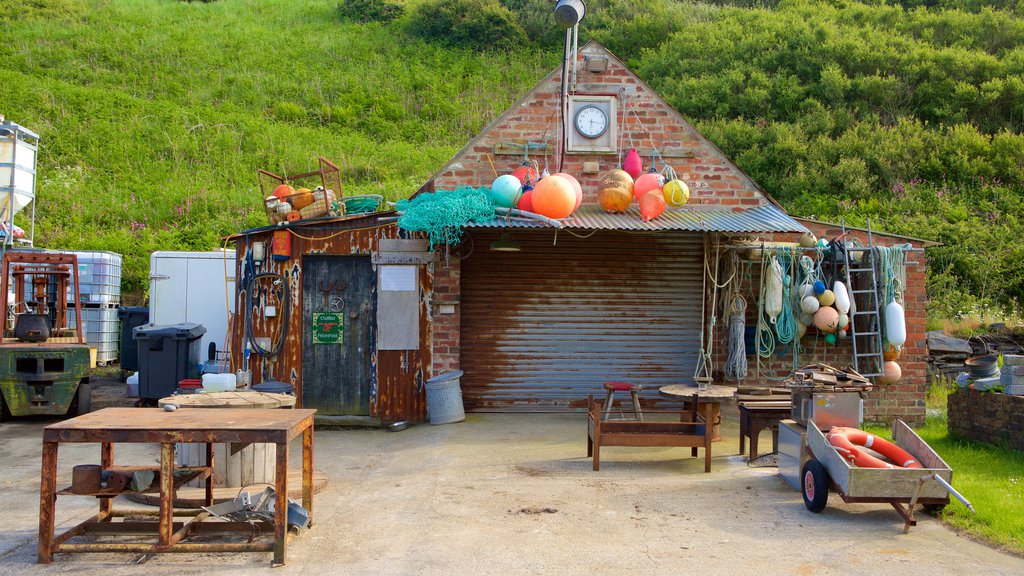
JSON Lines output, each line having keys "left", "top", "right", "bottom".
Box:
{"left": 490, "top": 166, "right": 583, "bottom": 219}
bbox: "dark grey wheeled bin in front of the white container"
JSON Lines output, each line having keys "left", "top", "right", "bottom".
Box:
{"left": 132, "top": 323, "right": 206, "bottom": 399}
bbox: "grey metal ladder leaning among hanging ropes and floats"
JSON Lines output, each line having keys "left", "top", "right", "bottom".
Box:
{"left": 842, "top": 218, "right": 885, "bottom": 377}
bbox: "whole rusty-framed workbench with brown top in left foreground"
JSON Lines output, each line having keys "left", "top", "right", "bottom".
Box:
{"left": 38, "top": 408, "right": 316, "bottom": 566}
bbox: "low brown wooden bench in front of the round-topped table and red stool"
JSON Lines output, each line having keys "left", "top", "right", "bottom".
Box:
{"left": 587, "top": 395, "right": 712, "bottom": 472}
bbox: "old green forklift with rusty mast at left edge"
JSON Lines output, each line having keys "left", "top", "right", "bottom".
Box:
{"left": 0, "top": 252, "right": 92, "bottom": 419}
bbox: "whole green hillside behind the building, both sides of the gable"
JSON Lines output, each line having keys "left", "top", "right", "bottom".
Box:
{"left": 6, "top": 0, "right": 1024, "bottom": 316}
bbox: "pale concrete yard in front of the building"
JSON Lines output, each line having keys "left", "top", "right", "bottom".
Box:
{"left": 0, "top": 407, "right": 1024, "bottom": 576}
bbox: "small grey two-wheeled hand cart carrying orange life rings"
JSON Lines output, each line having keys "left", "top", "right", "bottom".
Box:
{"left": 800, "top": 418, "right": 974, "bottom": 533}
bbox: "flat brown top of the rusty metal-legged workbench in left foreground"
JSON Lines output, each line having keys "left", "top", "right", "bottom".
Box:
{"left": 43, "top": 408, "right": 316, "bottom": 443}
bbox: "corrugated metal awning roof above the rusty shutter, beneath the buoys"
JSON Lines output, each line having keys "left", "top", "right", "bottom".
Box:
{"left": 465, "top": 199, "right": 809, "bottom": 233}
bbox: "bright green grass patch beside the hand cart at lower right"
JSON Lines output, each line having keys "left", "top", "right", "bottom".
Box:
{"left": 869, "top": 416, "right": 1024, "bottom": 554}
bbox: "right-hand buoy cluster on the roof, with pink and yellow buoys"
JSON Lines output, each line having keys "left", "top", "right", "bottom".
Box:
{"left": 597, "top": 167, "right": 690, "bottom": 221}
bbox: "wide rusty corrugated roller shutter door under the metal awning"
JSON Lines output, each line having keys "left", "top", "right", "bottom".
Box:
{"left": 461, "top": 230, "right": 703, "bottom": 412}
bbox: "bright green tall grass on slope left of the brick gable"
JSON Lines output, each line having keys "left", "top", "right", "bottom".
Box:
{"left": 0, "top": 0, "right": 557, "bottom": 293}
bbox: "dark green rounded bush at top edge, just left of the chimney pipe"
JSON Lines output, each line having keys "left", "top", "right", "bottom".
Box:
{"left": 410, "top": 0, "right": 528, "bottom": 50}
